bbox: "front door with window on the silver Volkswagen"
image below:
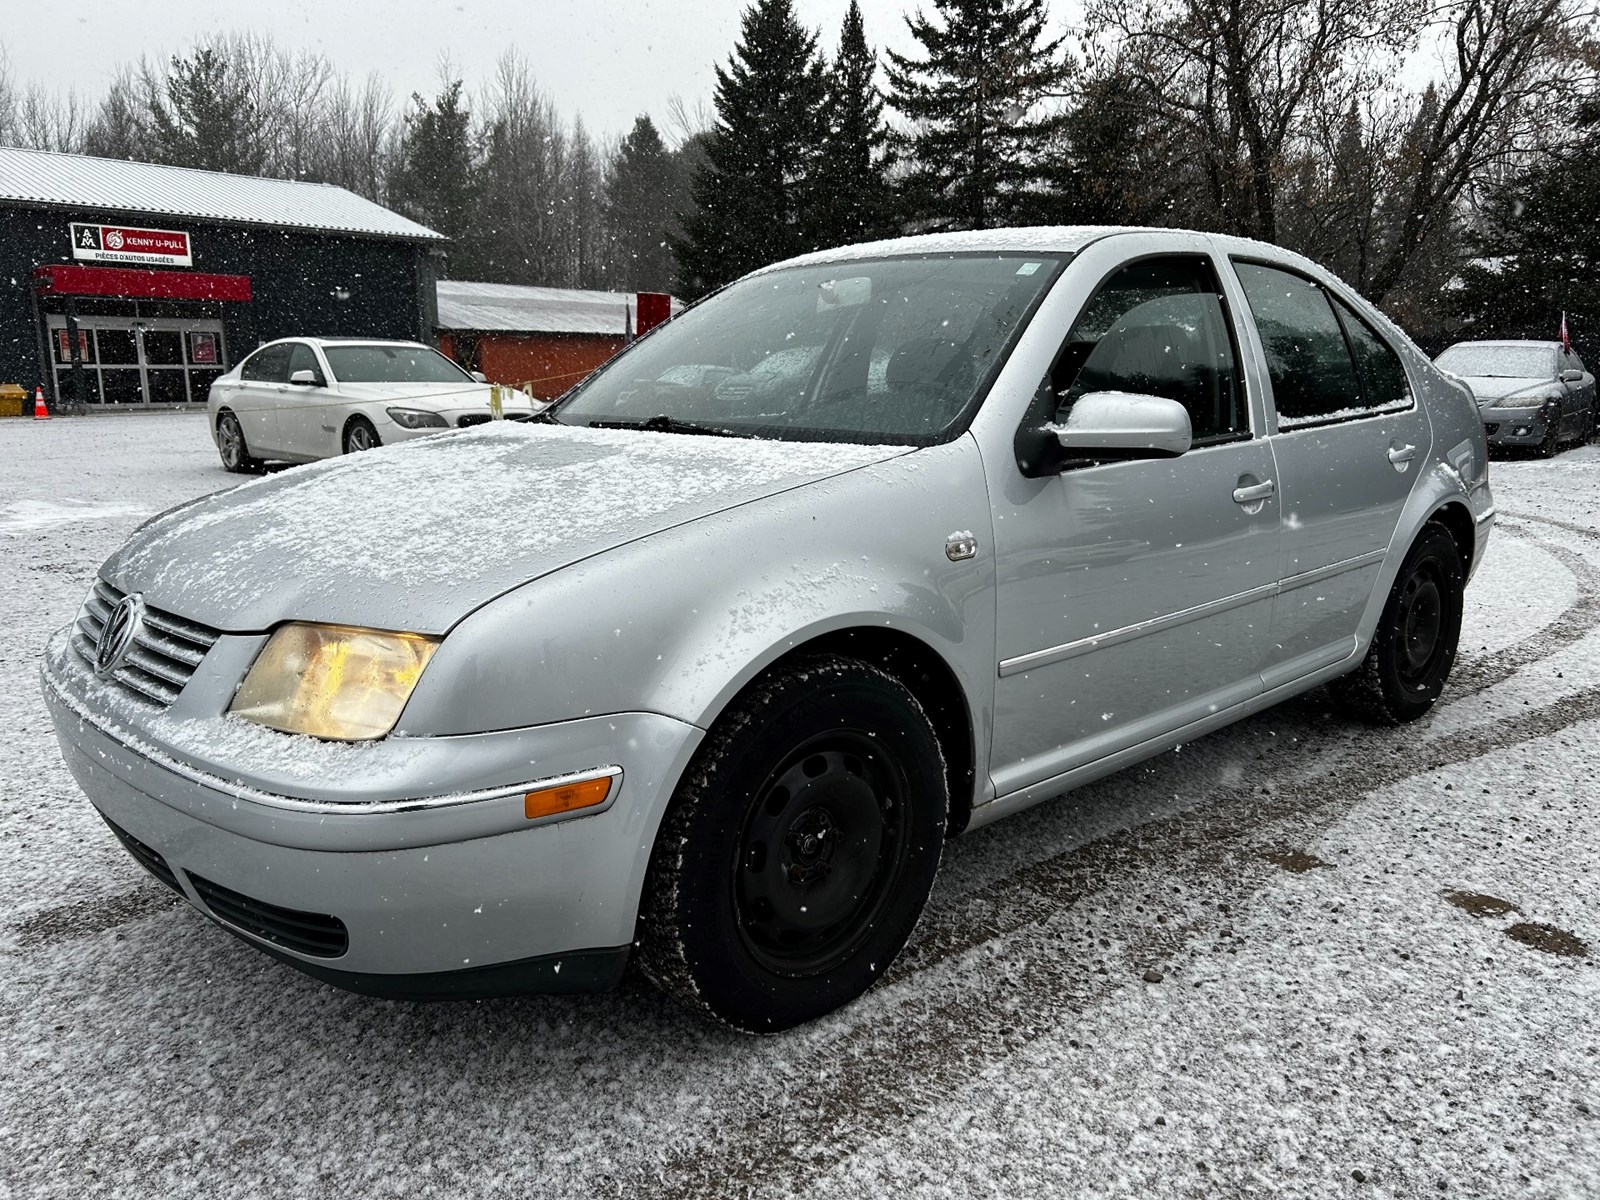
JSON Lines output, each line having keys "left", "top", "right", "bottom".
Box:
{"left": 990, "top": 254, "right": 1280, "bottom": 795}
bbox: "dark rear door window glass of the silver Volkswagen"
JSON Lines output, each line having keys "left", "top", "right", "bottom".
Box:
{"left": 1234, "top": 262, "right": 1411, "bottom": 429}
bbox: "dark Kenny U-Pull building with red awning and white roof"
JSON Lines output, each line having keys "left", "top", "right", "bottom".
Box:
{"left": 0, "top": 147, "right": 445, "bottom": 410}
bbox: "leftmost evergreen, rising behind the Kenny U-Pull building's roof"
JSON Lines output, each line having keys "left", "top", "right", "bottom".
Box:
{"left": 146, "top": 46, "right": 267, "bottom": 174}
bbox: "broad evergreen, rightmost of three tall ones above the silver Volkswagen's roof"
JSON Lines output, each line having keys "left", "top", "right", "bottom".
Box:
{"left": 888, "top": 0, "right": 1069, "bottom": 229}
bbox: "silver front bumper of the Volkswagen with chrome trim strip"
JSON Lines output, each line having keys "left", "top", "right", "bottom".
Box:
{"left": 43, "top": 638, "right": 701, "bottom": 998}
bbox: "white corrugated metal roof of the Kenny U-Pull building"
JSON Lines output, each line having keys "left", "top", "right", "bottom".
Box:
{"left": 0, "top": 146, "right": 443, "bottom": 242}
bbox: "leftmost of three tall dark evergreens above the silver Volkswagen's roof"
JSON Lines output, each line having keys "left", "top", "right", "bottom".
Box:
{"left": 672, "top": 0, "right": 826, "bottom": 296}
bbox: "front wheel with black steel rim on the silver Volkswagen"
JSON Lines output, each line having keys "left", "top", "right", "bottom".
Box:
{"left": 638, "top": 654, "right": 950, "bottom": 1034}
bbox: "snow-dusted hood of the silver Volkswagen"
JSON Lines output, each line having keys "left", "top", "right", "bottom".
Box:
{"left": 101, "top": 422, "right": 910, "bottom": 634}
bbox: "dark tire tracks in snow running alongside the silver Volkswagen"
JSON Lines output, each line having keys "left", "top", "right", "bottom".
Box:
{"left": 646, "top": 524, "right": 1600, "bottom": 1200}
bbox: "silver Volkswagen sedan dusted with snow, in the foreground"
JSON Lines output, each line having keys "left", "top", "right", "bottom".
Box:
{"left": 43, "top": 229, "right": 1494, "bottom": 1030}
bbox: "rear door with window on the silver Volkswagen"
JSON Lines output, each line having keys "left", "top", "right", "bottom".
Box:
{"left": 1234, "top": 259, "right": 1432, "bottom": 688}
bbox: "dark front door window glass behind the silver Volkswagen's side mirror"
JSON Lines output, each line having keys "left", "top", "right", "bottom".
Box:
{"left": 1051, "top": 258, "right": 1250, "bottom": 443}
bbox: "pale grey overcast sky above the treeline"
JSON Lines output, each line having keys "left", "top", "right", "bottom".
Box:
{"left": 0, "top": 0, "right": 1011, "bottom": 136}
